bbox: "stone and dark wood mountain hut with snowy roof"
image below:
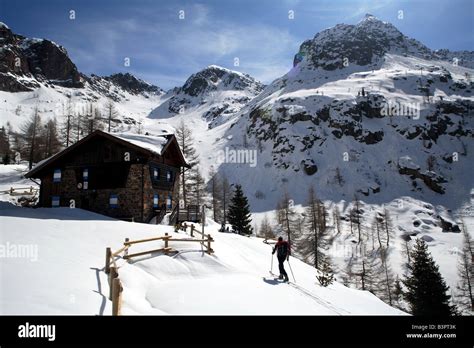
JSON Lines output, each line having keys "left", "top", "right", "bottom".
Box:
{"left": 25, "top": 130, "right": 200, "bottom": 223}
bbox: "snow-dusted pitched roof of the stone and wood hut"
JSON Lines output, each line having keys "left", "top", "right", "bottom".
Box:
{"left": 25, "top": 130, "right": 188, "bottom": 178}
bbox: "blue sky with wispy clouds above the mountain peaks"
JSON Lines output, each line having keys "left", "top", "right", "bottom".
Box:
{"left": 0, "top": 0, "right": 474, "bottom": 89}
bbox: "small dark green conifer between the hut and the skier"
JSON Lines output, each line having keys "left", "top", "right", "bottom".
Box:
{"left": 227, "top": 185, "right": 252, "bottom": 235}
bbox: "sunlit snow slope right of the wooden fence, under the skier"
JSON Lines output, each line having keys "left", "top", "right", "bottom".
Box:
{"left": 120, "top": 220, "right": 401, "bottom": 315}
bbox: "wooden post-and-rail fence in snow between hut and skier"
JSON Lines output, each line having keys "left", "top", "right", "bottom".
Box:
{"left": 105, "top": 231, "right": 214, "bottom": 315}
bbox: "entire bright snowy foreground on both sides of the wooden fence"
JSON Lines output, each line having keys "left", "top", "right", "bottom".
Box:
{"left": 0, "top": 166, "right": 403, "bottom": 315}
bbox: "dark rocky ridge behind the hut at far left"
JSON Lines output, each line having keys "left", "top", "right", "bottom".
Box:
{"left": 0, "top": 23, "right": 163, "bottom": 97}
